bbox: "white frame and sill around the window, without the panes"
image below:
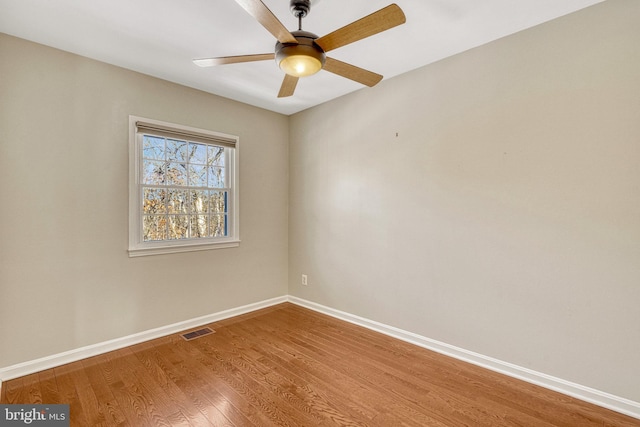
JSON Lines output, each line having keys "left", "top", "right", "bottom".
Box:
{"left": 128, "top": 116, "right": 240, "bottom": 257}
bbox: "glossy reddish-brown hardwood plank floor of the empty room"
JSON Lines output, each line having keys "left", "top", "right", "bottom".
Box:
{"left": 0, "top": 303, "right": 640, "bottom": 427}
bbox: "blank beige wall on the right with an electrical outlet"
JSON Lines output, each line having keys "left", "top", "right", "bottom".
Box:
{"left": 289, "top": 0, "right": 640, "bottom": 401}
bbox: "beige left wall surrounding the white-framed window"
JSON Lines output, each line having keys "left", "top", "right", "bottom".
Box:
{"left": 0, "top": 35, "right": 289, "bottom": 367}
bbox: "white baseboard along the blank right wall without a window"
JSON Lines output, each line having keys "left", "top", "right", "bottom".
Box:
{"left": 288, "top": 296, "right": 640, "bottom": 419}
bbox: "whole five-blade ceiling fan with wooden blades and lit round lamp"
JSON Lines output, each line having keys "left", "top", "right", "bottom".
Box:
{"left": 193, "top": 0, "right": 406, "bottom": 98}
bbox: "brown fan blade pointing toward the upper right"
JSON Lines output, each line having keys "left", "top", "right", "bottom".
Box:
{"left": 316, "top": 3, "right": 407, "bottom": 52}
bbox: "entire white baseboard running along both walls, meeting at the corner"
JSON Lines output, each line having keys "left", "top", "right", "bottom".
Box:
{"left": 0, "top": 295, "right": 640, "bottom": 419}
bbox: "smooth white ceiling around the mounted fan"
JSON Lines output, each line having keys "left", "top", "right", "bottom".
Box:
{"left": 0, "top": 0, "right": 602, "bottom": 114}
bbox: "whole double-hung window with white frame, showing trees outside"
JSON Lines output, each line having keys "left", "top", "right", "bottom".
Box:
{"left": 129, "top": 116, "right": 240, "bottom": 256}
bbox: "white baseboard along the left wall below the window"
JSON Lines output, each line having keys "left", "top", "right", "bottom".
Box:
{"left": 0, "top": 296, "right": 287, "bottom": 387}
